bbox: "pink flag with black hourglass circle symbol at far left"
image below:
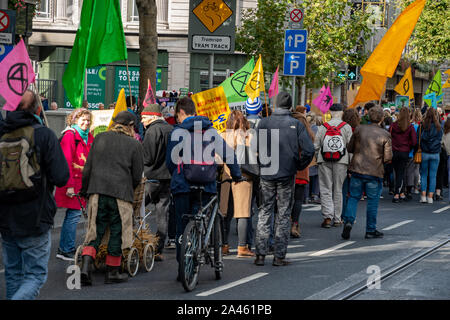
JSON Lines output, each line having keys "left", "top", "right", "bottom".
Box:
{"left": 0, "top": 39, "right": 35, "bottom": 111}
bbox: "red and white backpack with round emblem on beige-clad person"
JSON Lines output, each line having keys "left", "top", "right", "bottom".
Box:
{"left": 321, "top": 122, "right": 347, "bottom": 162}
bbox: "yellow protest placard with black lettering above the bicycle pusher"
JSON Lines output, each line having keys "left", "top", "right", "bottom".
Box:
{"left": 192, "top": 86, "right": 230, "bottom": 133}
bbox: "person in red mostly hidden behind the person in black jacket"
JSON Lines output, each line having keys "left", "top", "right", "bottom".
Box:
{"left": 291, "top": 106, "right": 315, "bottom": 238}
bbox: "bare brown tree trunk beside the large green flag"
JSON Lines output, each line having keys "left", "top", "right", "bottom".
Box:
{"left": 135, "top": 0, "right": 158, "bottom": 114}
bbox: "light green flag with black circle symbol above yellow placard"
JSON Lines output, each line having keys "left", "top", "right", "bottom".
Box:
{"left": 219, "top": 57, "right": 255, "bottom": 103}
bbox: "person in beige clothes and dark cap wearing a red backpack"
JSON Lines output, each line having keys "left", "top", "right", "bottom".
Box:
{"left": 314, "top": 103, "right": 352, "bottom": 228}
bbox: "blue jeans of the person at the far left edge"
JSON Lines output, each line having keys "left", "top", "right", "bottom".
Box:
{"left": 3, "top": 229, "right": 51, "bottom": 300}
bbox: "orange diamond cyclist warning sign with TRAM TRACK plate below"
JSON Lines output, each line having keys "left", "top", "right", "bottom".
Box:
{"left": 188, "top": 0, "right": 236, "bottom": 54}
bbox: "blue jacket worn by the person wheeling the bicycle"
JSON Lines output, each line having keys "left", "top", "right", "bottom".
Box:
{"left": 166, "top": 116, "right": 241, "bottom": 194}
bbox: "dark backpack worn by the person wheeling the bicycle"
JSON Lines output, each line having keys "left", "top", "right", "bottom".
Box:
{"left": 181, "top": 130, "right": 217, "bottom": 185}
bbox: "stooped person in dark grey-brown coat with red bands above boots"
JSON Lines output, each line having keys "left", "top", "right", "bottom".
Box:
{"left": 80, "top": 111, "right": 144, "bottom": 285}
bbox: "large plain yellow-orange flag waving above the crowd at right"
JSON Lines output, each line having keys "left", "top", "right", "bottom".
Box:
{"left": 350, "top": 0, "right": 426, "bottom": 107}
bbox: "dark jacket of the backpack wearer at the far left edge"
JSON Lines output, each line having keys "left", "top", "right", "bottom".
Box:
{"left": 0, "top": 111, "right": 69, "bottom": 237}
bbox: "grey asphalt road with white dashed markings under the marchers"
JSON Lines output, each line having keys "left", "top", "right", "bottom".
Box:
{"left": 0, "top": 190, "right": 450, "bottom": 301}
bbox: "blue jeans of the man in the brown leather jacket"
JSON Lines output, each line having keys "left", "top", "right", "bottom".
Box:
{"left": 342, "top": 175, "right": 383, "bottom": 232}
